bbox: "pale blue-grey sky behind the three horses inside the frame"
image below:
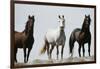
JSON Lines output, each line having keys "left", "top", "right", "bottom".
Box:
{"left": 15, "top": 4, "right": 94, "bottom": 62}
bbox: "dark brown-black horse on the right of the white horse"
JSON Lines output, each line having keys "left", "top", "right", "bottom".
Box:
{"left": 69, "top": 15, "right": 91, "bottom": 57}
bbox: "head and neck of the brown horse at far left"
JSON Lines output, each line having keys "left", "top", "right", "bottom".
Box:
{"left": 26, "top": 15, "right": 35, "bottom": 33}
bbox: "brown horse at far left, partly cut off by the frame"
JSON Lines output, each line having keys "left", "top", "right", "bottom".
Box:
{"left": 14, "top": 15, "right": 35, "bottom": 63}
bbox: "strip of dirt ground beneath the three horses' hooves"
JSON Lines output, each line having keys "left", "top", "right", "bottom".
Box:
{"left": 15, "top": 56, "right": 94, "bottom": 66}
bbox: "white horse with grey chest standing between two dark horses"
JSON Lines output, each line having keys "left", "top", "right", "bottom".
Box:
{"left": 41, "top": 15, "right": 66, "bottom": 59}
